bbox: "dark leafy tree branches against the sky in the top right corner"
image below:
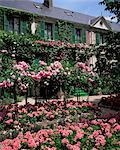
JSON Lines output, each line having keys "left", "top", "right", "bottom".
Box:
{"left": 100, "top": 0, "right": 120, "bottom": 22}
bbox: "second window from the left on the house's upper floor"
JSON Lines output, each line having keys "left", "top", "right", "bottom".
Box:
{"left": 45, "top": 23, "right": 53, "bottom": 40}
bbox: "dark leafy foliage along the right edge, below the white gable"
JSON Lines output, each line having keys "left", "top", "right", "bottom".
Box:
{"left": 96, "top": 32, "right": 120, "bottom": 94}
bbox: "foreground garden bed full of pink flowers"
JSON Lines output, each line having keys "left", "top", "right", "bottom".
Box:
{"left": 0, "top": 100, "right": 120, "bottom": 150}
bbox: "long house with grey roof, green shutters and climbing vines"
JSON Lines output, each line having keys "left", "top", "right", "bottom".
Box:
{"left": 0, "top": 0, "right": 120, "bottom": 45}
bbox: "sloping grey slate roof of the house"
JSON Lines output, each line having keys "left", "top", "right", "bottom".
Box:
{"left": 0, "top": 0, "right": 120, "bottom": 31}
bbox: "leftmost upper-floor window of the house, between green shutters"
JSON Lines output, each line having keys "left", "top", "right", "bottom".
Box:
{"left": 8, "top": 18, "right": 20, "bottom": 33}
